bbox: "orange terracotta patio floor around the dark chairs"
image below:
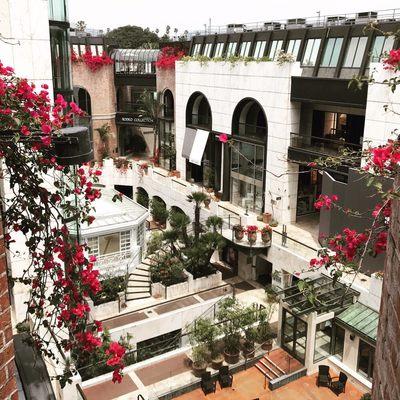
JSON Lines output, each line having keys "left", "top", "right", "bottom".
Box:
{"left": 176, "top": 367, "right": 362, "bottom": 400}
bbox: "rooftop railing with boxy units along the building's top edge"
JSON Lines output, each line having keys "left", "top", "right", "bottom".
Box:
{"left": 187, "top": 8, "right": 400, "bottom": 38}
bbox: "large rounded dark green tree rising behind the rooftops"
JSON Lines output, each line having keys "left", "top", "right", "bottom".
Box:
{"left": 106, "top": 25, "right": 160, "bottom": 49}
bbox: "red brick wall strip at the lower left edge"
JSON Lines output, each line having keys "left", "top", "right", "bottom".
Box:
{"left": 0, "top": 223, "right": 18, "bottom": 400}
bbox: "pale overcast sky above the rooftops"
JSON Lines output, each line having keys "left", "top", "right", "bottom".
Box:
{"left": 69, "top": 0, "right": 399, "bottom": 34}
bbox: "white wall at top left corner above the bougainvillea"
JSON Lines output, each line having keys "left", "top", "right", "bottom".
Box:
{"left": 0, "top": 0, "right": 53, "bottom": 97}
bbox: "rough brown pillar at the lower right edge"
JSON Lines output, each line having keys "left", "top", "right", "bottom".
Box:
{"left": 372, "top": 178, "right": 400, "bottom": 400}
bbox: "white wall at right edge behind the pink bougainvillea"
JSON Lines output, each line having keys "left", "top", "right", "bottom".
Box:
{"left": 364, "top": 63, "right": 400, "bottom": 147}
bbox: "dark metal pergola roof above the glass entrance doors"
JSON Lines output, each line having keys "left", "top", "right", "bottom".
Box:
{"left": 277, "top": 275, "right": 360, "bottom": 316}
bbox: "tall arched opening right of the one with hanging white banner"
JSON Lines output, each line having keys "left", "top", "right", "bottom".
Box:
{"left": 225, "top": 98, "right": 268, "bottom": 214}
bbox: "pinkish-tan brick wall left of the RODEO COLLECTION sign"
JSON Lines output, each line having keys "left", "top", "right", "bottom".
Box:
{"left": 72, "top": 62, "right": 118, "bottom": 160}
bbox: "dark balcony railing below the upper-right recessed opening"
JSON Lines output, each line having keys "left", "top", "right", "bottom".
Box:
{"left": 290, "top": 132, "right": 362, "bottom": 156}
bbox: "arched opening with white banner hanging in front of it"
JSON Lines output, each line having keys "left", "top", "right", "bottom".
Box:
{"left": 185, "top": 92, "right": 222, "bottom": 191}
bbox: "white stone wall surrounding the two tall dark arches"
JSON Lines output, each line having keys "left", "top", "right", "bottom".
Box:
{"left": 175, "top": 62, "right": 301, "bottom": 222}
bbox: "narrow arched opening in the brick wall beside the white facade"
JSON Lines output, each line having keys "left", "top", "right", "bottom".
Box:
{"left": 159, "top": 89, "right": 176, "bottom": 171}
